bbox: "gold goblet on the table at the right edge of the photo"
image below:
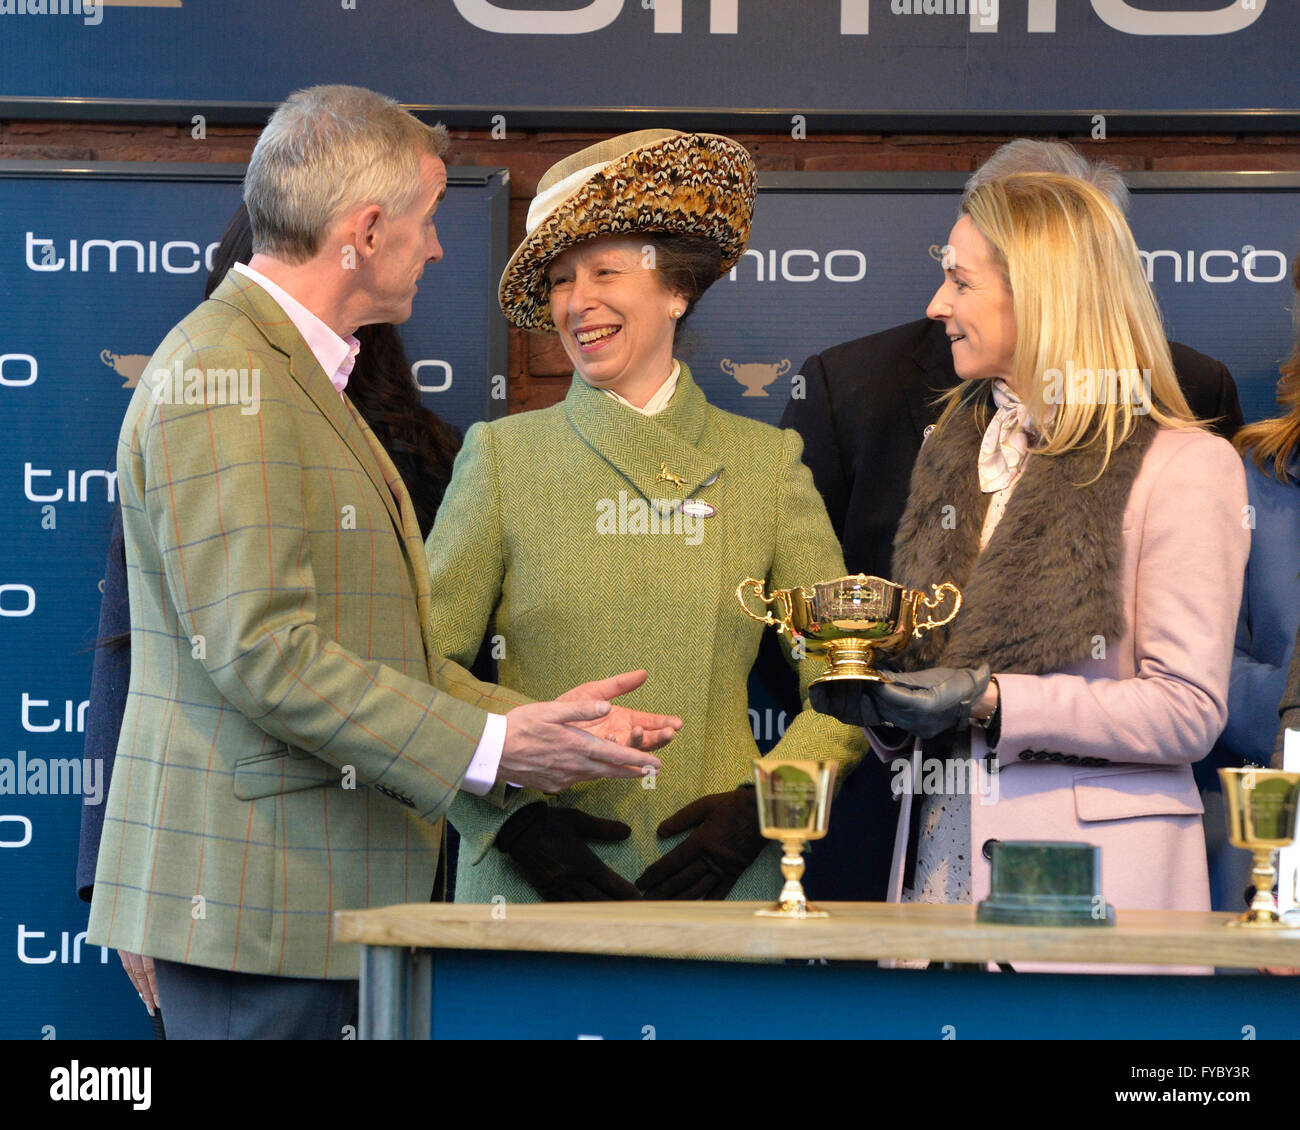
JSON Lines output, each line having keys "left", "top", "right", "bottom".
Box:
{"left": 1218, "top": 767, "right": 1300, "bottom": 930}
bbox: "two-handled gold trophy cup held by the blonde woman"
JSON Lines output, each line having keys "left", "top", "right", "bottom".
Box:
{"left": 736, "top": 573, "right": 962, "bottom": 683}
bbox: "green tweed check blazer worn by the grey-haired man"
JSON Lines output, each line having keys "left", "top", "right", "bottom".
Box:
{"left": 88, "top": 274, "right": 528, "bottom": 978}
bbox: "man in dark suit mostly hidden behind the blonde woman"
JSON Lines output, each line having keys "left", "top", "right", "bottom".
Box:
{"left": 781, "top": 138, "right": 1243, "bottom": 901}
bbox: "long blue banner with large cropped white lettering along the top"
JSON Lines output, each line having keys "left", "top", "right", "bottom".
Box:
{"left": 0, "top": 0, "right": 1300, "bottom": 118}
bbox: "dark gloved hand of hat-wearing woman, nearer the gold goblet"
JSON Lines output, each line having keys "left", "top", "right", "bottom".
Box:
{"left": 637, "top": 788, "right": 767, "bottom": 899}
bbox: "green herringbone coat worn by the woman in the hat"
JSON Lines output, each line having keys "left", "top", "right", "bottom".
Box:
{"left": 426, "top": 365, "right": 863, "bottom": 902}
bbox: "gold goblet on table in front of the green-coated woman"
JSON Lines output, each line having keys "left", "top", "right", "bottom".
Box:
{"left": 754, "top": 758, "right": 839, "bottom": 918}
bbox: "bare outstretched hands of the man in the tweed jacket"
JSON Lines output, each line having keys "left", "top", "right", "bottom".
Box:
{"left": 498, "top": 671, "right": 681, "bottom": 792}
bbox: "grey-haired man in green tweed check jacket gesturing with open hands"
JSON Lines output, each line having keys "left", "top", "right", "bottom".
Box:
{"left": 88, "top": 87, "right": 680, "bottom": 1039}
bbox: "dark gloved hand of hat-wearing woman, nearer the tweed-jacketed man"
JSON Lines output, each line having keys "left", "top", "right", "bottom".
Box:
{"left": 497, "top": 801, "right": 641, "bottom": 902}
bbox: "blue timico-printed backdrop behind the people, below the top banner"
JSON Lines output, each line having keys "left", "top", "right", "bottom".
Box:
{"left": 0, "top": 166, "right": 1300, "bottom": 1039}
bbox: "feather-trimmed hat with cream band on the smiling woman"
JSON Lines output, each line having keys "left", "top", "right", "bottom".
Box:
{"left": 498, "top": 130, "right": 757, "bottom": 333}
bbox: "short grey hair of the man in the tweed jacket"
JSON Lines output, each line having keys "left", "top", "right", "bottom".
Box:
{"left": 244, "top": 86, "right": 451, "bottom": 263}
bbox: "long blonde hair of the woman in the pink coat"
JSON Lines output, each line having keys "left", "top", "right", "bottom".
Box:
{"left": 940, "top": 173, "right": 1199, "bottom": 481}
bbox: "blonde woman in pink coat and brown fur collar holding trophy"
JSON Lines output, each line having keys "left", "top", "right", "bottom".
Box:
{"left": 814, "top": 174, "right": 1249, "bottom": 969}
